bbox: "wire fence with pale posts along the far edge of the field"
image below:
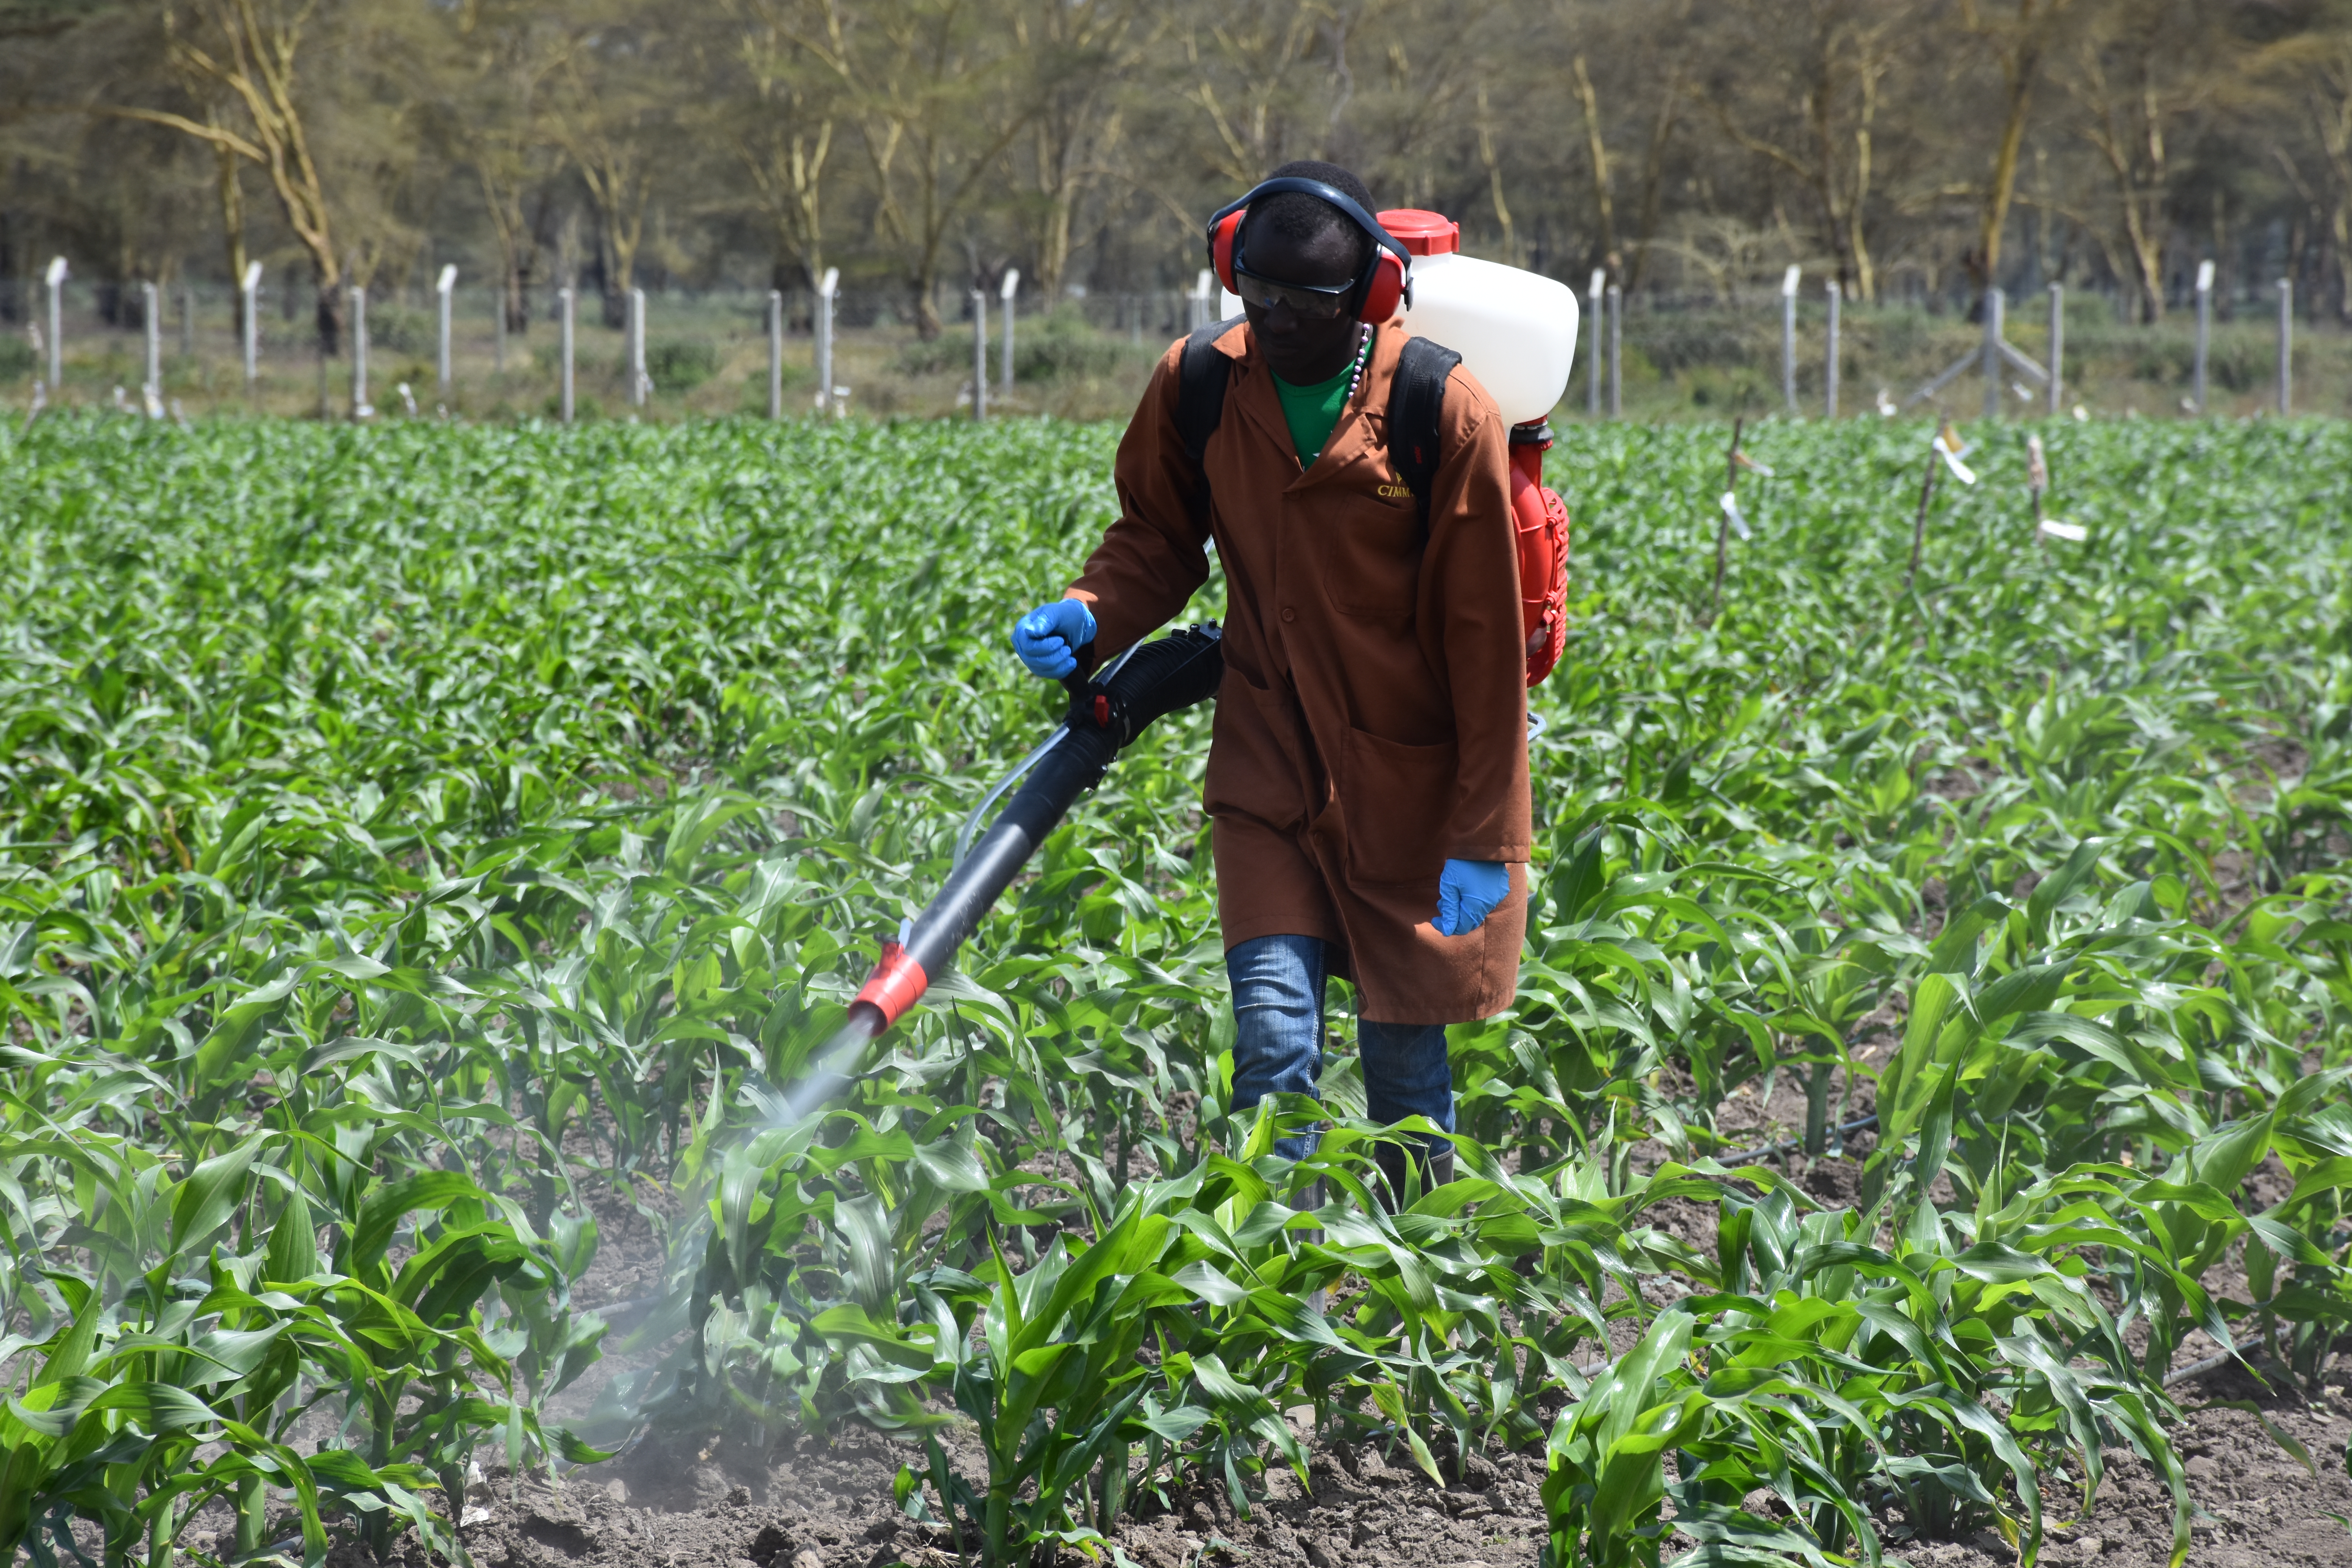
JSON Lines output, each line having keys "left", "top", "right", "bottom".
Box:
{"left": 0, "top": 278, "right": 2352, "bottom": 421}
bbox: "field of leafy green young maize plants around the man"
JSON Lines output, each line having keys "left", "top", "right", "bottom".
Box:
{"left": 0, "top": 416, "right": 2352, "bottom": 1568}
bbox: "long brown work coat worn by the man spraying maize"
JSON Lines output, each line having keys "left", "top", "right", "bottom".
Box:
{"left": 1068, "top": 325, "right": 1529, "bottom": 1023}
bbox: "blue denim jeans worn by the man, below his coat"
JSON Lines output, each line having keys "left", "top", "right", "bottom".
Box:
{"left": 1225, "top": 936, "right": 1454, "bottom": 1159}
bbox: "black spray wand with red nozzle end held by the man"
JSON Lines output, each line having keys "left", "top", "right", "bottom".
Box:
{"left": 842, "top": 625, "right": 1225, "bottom": 1039}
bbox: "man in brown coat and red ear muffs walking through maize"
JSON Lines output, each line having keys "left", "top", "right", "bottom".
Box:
{"left": 1014, "top": 162, "right": 1529, "bottom": 1194}
